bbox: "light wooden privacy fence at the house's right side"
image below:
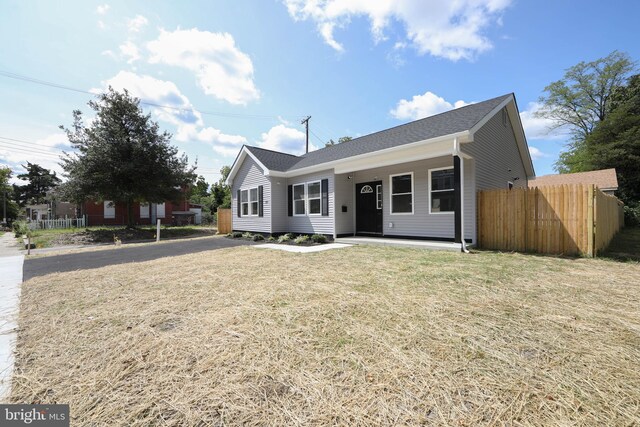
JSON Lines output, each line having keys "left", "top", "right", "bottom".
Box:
{"left": 478, "top": 184, "right": 624, "bottom": 256}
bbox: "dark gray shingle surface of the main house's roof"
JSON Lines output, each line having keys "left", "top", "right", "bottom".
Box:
{"left": 242, "top": 94, "right": 512, "bottom": 172}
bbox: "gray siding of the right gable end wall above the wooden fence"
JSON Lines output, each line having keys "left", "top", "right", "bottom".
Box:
{"left": 462, "top": 108, "right": 527, "bottom": 190}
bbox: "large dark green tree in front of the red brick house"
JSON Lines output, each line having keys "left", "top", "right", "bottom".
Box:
{"left": 60, "top": 87, "right": 196, "bottom": 227}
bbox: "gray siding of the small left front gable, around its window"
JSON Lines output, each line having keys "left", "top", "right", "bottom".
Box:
{"left": 231, "top": 156, "right": 271, "bottom": 233}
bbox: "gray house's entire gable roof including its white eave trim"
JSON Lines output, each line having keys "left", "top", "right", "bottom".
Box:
{"left": 228, "top": 93, "right": 534, "bottom": 181}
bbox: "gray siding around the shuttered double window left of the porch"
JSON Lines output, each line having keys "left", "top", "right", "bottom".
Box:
{"left": 283, "top": 170, "right": 335, "bottom": 236}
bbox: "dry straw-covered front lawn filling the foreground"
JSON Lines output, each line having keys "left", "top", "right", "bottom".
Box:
{"left": 11, "top": 247, "right": 640, "bottom": 426}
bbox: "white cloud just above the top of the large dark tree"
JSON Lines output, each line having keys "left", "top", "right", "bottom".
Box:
{"left": 92, "top": 71, "right": 202, "bottom": 126}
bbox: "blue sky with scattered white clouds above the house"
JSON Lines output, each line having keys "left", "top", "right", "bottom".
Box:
{"left": 0, "top": 0, "right": 640, "bottom": 183}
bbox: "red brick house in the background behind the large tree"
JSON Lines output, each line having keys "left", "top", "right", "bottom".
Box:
{"left": 82, "top": 200, "right": 200, "bottom": 225}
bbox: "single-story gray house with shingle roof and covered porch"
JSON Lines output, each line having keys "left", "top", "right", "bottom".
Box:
{"left": 227, "top": 94, "right": 535, "bottom": 243}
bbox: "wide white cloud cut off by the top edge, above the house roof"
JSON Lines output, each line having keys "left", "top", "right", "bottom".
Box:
{"left": 283, "top": 0, "right": 512, "bottom": 61}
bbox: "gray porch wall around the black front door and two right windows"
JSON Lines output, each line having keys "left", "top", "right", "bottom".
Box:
{"left": 350, "top": 156, "right": 475, "bottom": 240}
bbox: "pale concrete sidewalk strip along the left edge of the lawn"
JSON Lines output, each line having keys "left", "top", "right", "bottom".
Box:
{"left": 0, "top": 232, "right": 24, "bottom": 403}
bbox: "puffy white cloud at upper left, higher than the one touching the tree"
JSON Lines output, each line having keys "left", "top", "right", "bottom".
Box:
{"left": 147, "top": 28, "right": 260, "bottom": 105}
